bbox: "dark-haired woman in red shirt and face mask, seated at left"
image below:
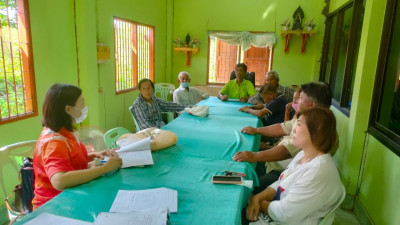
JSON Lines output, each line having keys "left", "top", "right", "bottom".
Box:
{"left": 32, "top": 84, "right": 122, "bottom": 209}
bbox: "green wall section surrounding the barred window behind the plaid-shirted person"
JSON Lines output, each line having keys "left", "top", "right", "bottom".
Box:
{"left": 96, "top": 0, "right": 170, "bottom": 130}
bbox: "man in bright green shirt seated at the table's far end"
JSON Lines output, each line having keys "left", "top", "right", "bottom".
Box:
{"left": 218, "top": 63, "right": 257, "bottom": 102}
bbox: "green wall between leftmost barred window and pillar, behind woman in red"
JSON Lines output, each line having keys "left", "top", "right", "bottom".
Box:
{"left": 0, "top": 0, "right": 77, "bottom": 200}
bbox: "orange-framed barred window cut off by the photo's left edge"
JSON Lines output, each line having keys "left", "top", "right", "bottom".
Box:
{"left": 0, "top": 0, "right": 37, "bottom": 124}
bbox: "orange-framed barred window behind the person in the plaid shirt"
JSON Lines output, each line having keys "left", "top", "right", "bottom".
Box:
{"left": 114, "top": 17, "right": 154, "bottom": 94}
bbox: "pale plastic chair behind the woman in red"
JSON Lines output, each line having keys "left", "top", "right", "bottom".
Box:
{"left": 0, "top": 140, "right": 37, "bottom": 221}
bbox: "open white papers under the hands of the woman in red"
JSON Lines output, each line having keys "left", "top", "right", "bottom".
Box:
{"left": 109, "top": 137, "right": 154, "bottom": 168}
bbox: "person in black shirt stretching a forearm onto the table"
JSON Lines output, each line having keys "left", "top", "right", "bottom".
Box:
{"left": 239, "top": 84, "right": 287, "bottom": 126}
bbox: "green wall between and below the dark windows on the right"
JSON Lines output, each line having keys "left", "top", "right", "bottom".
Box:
{"left": 331, "top": 1, "right": 400, "bottom": 225}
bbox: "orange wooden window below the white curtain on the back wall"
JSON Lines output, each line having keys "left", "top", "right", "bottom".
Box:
{"left": 207, "top": 37, "right": 272, "bottom": 86}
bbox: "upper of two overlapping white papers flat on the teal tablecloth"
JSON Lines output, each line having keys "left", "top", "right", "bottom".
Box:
{"left": 110, "top": 188, "right": 178, "bottom": 213}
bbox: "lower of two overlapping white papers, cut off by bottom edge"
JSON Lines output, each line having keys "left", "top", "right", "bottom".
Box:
{"left": 94, "top": 209, "right": 168, "bottom": 225}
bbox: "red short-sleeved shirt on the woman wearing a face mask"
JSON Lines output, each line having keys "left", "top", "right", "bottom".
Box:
{"left": 32, "top": 127, "right": 88, "bottom": 208}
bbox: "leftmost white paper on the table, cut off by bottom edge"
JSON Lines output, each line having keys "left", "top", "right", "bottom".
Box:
{"left": 25, "top": 212, "right": 93, "bottom": 225}
